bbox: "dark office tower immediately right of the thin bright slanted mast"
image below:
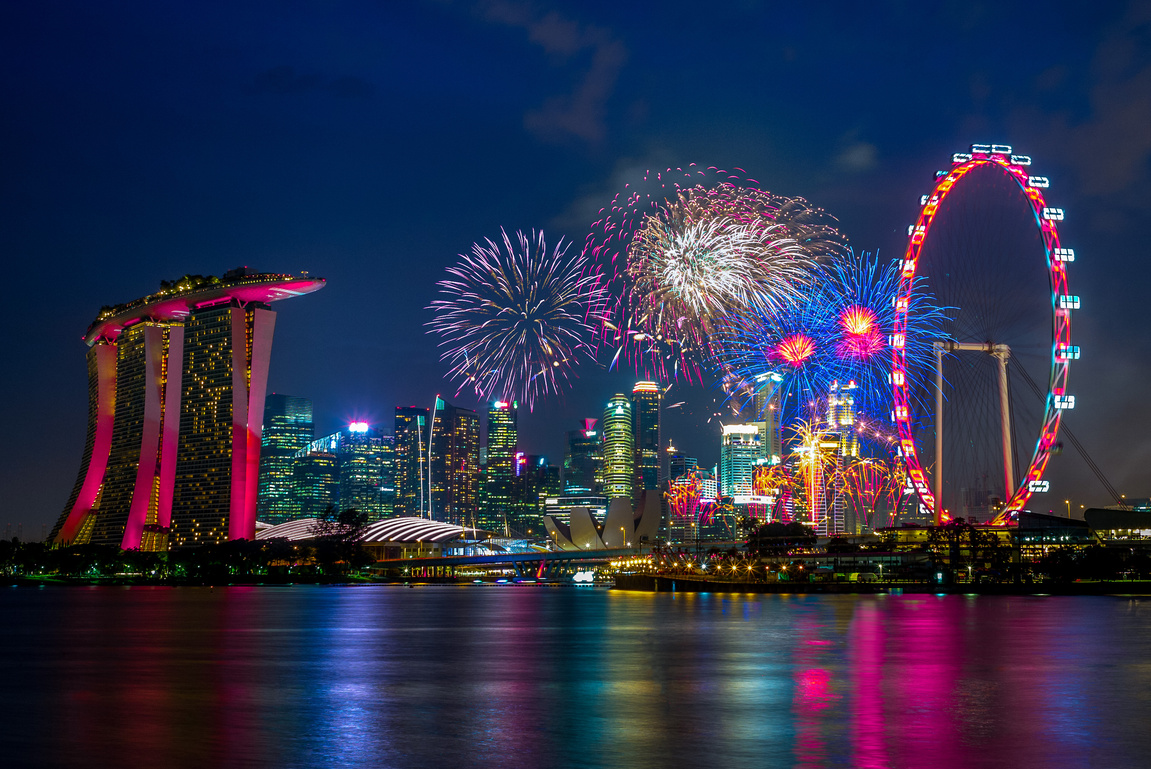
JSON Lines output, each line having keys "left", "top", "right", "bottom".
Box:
{"left": 429, "top": 396, "right": 480, "bottom": 526}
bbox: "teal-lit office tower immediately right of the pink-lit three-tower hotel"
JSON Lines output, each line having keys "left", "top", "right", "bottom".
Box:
{"left": 256, "top": 393, "right": 314, "bottom": 524}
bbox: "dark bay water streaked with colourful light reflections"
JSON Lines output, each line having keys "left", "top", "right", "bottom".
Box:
{"left": 0, "top": 586, "right": 1151, "bottom": 769}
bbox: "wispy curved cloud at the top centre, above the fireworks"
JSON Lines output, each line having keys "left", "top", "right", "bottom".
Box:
{"left": 483, "top": 0, "right": 627, "bottom": 144}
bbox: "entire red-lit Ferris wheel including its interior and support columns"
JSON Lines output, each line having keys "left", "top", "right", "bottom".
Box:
{"left": 892, "top": 144, "right": 1078, "bottom": 523}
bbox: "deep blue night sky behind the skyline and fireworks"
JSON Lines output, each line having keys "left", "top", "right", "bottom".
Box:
{"left": 0, "top": 0, "right": 1151, "bottom": 539}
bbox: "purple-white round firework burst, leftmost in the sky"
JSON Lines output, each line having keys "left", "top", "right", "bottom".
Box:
{"left": 428, "top": 229, "right": 603, "bottom": 409}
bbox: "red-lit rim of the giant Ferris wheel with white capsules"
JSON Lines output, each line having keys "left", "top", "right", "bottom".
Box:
{"left": 891, "top": 144, "right": 1078, "bottom": 525}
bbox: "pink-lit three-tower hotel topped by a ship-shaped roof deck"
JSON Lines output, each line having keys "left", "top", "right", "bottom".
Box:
{"left": 49, "top": 268, "right": 323, "bottom": 550}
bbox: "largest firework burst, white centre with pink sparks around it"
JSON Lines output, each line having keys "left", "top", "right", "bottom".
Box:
{"left": 585, "top": 166, "right": 843, "bottom": 381}
